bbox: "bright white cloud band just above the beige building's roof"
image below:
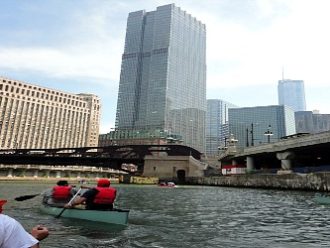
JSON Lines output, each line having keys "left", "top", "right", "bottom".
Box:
{"left": 0, "top": 46, "right": 120, "bottom": 85}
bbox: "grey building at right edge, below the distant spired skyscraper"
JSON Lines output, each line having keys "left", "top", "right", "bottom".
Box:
{"left": 295, "top": 110, "right": 330, "bottom": 133}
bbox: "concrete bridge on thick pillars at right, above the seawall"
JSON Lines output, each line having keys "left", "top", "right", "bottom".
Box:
{"left": 219, "top": 131, "right": 330, "bottom": 171}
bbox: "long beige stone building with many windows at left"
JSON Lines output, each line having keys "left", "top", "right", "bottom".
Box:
{"left": 0, "top": 77, "right": 100, "bottom": 149}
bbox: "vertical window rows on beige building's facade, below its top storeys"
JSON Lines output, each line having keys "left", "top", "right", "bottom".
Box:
{"left": 0, "top": 98, "right": 97, "bottom": 148}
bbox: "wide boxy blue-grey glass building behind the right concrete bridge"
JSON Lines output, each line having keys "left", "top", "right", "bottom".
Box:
{"left": 228, "top": 105, "right": 296, "bottom": 148}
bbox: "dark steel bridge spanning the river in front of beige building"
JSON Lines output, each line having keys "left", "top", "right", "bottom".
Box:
{"left": 0, "top": 144, "right": 201, "bottom": 171}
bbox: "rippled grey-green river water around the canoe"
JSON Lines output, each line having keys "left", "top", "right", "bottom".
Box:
{"left": 0, "top": 182, "right": 330, "bottom": 248}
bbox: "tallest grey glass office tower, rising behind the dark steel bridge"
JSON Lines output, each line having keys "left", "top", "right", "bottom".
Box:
{"left": 116, "top": 4, "right": 206, "bottom": 152}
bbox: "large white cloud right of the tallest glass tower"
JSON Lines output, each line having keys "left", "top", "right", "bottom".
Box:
{"left": 202, "top": 0, "right": 330, "bottom": 89}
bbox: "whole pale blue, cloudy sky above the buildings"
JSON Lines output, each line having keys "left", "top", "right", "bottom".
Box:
{"left": 0, "top": 0, "right": 330, "bottom": 133}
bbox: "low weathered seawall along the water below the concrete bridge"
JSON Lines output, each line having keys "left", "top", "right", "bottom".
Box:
{"left": 186, "top": 172, "right": 330, "bottom": 192}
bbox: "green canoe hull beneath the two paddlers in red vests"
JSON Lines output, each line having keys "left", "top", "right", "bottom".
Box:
{"left": 41, "top": 204, "right": 129, "bottom": 225}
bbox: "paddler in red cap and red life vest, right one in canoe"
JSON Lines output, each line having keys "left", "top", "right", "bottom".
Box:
{"left": 64, "top": 178, "right": 117, "bottom": 210}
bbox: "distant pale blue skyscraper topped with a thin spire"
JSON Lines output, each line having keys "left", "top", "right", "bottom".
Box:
{"left": 278, "top": 79, "right": 306, "bottom": 112}
